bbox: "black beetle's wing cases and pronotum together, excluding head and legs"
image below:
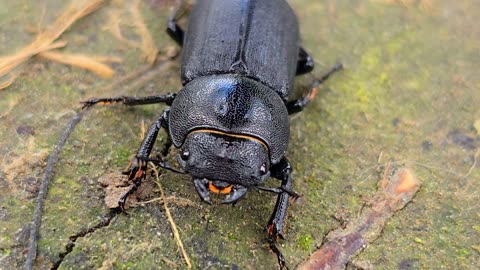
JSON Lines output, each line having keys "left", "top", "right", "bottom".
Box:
{"left": 169, "top": 0, "right": 300, "bottom": 164}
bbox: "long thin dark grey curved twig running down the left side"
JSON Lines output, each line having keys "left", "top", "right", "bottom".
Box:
{"left": 25, "top": 110, "right": 86, "bottom": 270}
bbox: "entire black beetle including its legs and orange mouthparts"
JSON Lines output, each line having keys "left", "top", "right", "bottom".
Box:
{"left": 84, "top": 0, "right": 342, "bottom": 268}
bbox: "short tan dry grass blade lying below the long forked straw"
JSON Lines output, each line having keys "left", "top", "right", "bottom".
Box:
{"left": 38, "top": 51, "right": 114, "bottom": 79}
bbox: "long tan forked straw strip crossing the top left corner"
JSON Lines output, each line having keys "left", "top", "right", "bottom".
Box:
{"left": 0, "top": 0, "right": 106, "bottom": 89}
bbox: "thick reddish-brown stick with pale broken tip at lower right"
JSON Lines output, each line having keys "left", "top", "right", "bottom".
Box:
{"left": 297, "top": 165, "right": 420, "bottom": 270}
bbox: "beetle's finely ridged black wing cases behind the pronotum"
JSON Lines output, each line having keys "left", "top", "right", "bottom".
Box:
{"left": 181, "top": 0, "right": 300, "bottom": 100}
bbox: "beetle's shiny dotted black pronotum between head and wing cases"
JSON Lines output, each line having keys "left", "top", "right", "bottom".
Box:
{"left": 169, "top": 74, "right": 290, "bottom": 164}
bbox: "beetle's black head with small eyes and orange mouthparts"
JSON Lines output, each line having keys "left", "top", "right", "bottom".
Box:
{"left": 178, "top": 129, "right": 270, "bottom": 203}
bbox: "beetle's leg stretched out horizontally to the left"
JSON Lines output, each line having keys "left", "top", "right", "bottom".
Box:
{"left": 82, "top": 93, "right": 176, "bottom": 109}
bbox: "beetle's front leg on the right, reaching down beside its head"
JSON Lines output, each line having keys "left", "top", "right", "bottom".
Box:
{"left": 265, "top": 158, "right": 292, "bottom": 269}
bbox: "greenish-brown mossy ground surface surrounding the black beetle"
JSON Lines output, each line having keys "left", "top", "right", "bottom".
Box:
{"left": 0, "top": 0, "right": 480, "bottom": 269}
